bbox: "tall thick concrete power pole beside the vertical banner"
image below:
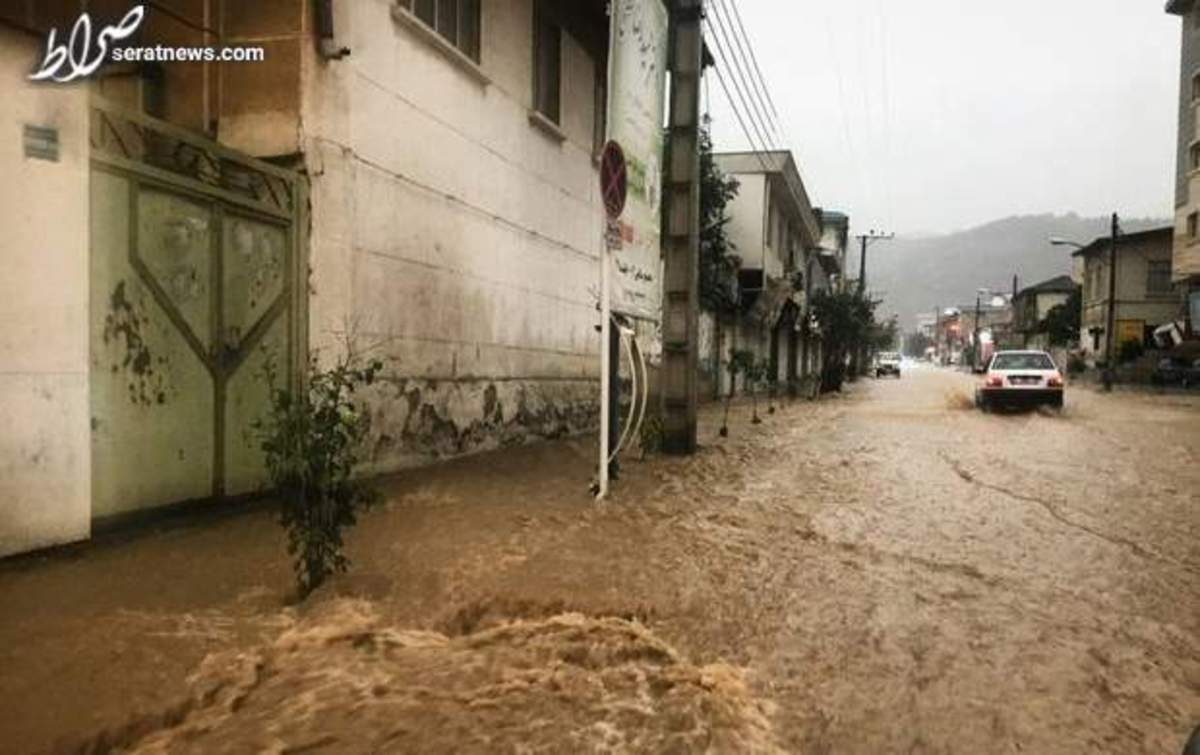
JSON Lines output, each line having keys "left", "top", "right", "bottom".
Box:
{"left": 662, "top": 0, "right": 704, "bottom": 455}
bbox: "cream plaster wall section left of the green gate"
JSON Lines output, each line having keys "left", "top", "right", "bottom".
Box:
{"left": 0, "top": 26, "right": 91, "bottom": 556}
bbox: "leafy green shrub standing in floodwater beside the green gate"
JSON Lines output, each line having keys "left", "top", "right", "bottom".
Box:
{"left": 253, "top": 355, "right": 383, "bottom": 599}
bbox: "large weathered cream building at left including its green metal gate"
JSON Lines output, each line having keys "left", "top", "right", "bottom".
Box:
{"left": 0, "top": 0, "right": 667, "bottom": 556}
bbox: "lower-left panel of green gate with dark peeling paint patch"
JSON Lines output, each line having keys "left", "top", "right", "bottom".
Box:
{"left": 90, "top": 170, "right": 216, "bottom": 517}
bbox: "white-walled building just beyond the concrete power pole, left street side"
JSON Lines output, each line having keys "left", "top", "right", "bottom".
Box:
{"left": 715, "top": 151, "right": 838, "bottom": 393}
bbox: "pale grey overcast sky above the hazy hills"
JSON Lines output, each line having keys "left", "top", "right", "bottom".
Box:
{"left": 708, "top": 0, "right": 1181, "bottom": 234}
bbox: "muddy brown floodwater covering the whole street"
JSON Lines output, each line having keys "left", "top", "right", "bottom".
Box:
{"left": 0, "top": 368, "right": 1200, "bottom": 755}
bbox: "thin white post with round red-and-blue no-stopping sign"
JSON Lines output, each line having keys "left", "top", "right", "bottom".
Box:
{"left": 596, "top": 142, "right": 629, "bottom": 499}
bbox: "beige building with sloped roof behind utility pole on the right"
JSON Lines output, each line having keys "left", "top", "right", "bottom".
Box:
{"left": 1074, "top": 227, "right": 1181, "bottom": 361}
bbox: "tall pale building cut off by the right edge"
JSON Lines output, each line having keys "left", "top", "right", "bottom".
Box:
{"left": 1166, "top": 0, "right": 1200, "bottom": 338}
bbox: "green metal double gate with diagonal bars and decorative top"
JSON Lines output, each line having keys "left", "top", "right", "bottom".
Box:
{"left": 90, "top": 100, "right": 307, "bottom": 519}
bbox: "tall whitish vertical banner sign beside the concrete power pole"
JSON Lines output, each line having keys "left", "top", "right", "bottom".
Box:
{"left": 607, "top": 0, "right": 668, "bottom": 333}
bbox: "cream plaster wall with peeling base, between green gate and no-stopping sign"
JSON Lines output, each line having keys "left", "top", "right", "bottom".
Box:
{"left": 302, "top": 0, "right": 602, "bottom": 471}
